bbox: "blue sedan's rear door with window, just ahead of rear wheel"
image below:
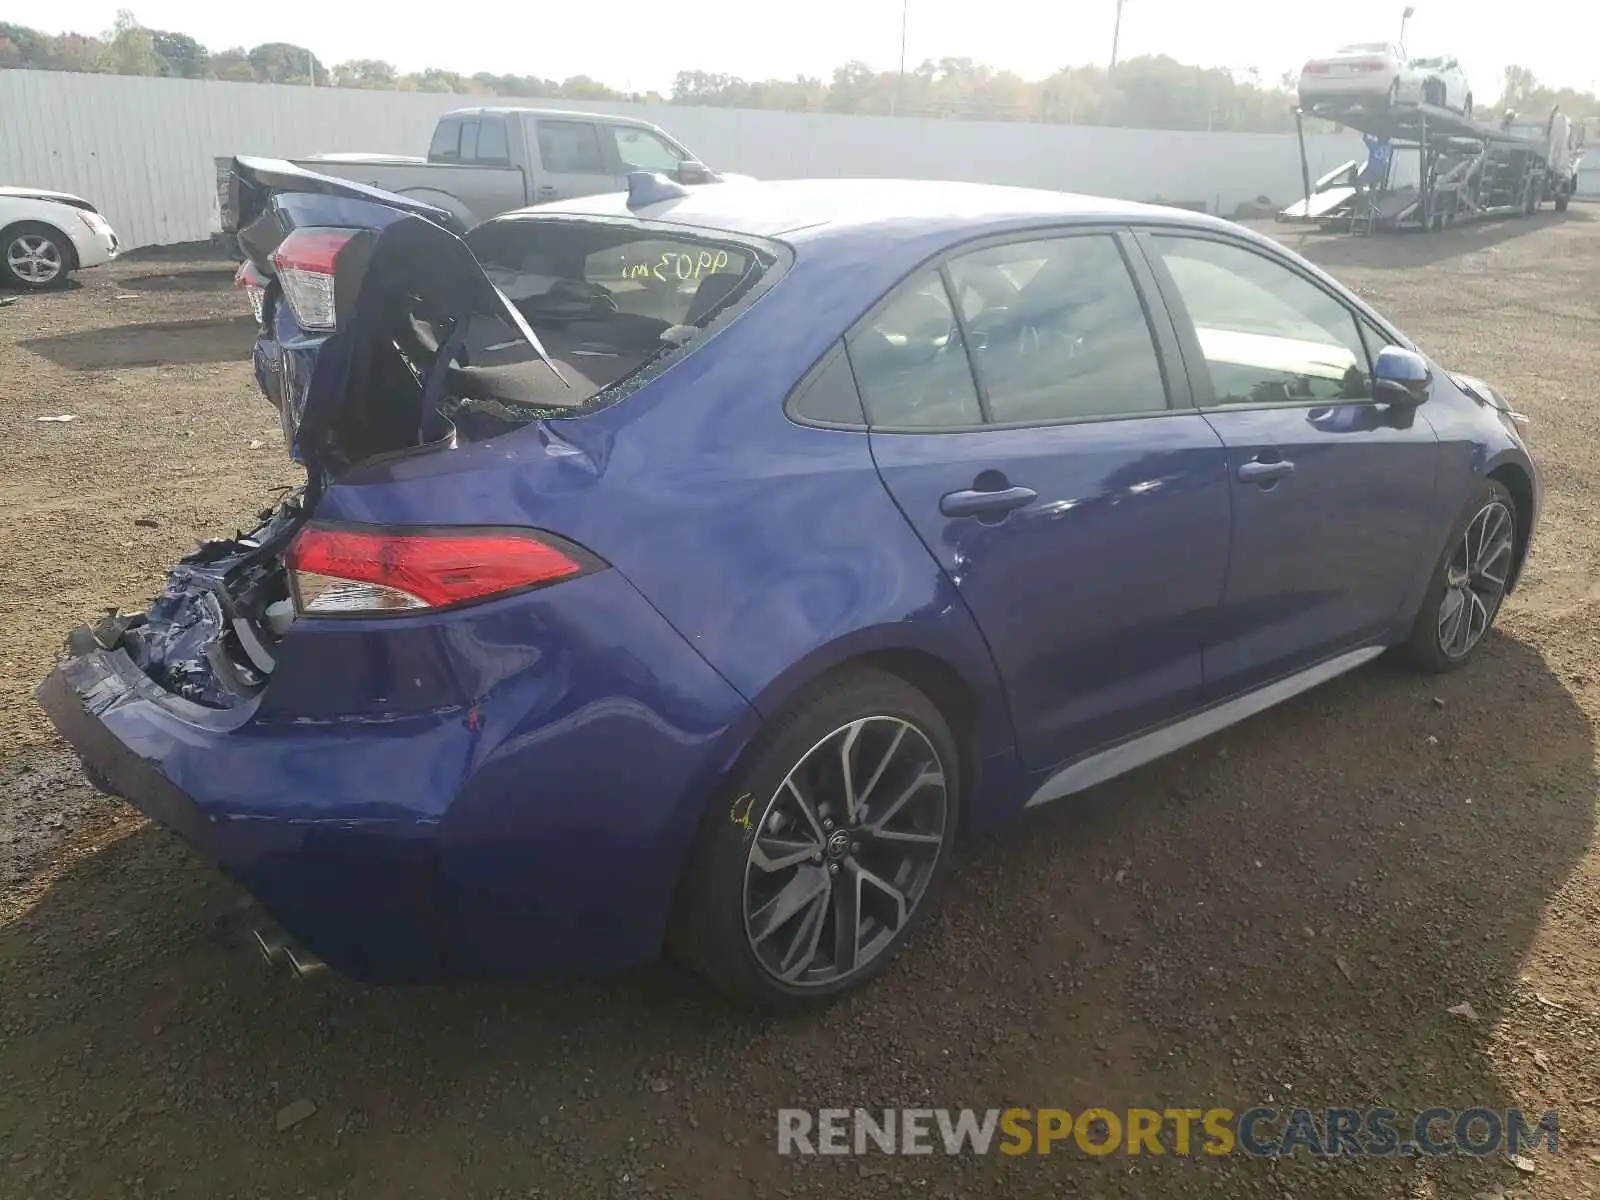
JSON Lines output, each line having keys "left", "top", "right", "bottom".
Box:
{"left": 846, "top": 230, "right": 1229, "bottom": 768}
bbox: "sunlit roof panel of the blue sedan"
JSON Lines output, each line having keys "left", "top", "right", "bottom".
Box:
{"left": 501, "top": 179, "right": 1234, "bottom": 243}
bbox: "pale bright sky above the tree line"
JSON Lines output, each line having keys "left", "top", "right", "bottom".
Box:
{"left": 5, "top": 0, "right": 1600, "bottom": 99}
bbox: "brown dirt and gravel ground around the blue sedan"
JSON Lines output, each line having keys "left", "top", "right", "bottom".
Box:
{"left": 0, "top": 219, "right": 1600, "bottom": 1200}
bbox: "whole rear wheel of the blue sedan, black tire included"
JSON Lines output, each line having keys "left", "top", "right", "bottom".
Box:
{"left": 669, "top": 669, "right": 960, "bottom": 1013}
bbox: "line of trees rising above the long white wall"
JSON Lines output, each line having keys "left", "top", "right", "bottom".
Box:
{"left": 0, "top": 10, "right": 1600, "bottom": 133}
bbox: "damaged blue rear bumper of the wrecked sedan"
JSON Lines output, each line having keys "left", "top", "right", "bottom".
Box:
{"left": 37, "top": 571, "right": 757, "bottom": 982}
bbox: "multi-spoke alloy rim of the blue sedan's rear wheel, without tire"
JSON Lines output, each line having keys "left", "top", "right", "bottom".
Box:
{"left": 744, "top": 715, "right": 950, "bottom": 987}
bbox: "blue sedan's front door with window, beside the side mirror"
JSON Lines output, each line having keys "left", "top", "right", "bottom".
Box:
{"left": 1141, "top": 230, "right": 1438, "bottom": 699}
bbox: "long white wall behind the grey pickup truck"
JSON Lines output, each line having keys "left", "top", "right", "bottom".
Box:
{"left": 0, "top": 70, "right": 1362, "bottom": 248}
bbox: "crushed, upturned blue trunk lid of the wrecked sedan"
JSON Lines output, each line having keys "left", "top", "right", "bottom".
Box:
{"left": 229, "top": 158, "right": 576, "bottom": 476}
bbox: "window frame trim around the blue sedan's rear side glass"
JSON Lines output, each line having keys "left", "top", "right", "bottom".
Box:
{"left": 784, "top": 219, "right": 1195, "bottom": 437}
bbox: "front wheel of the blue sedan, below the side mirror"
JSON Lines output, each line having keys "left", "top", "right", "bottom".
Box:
{"left": 1405, "top": 480, "right": 1517, "bottom": 672}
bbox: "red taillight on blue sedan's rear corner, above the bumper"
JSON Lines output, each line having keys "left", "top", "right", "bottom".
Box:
{"left": 285, "top": 525, "right": 600, "bottom": 616}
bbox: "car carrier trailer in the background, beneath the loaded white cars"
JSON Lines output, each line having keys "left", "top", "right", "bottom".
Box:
{"left": 1278, "top": 99, "right": 1582, "bottom": 234}
